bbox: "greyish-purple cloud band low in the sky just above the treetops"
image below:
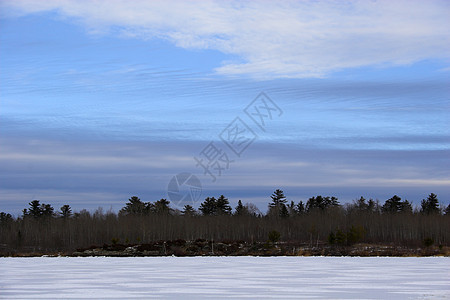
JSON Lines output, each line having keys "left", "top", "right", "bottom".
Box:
{"left": 0, "top": 136, "right": 450, "bottom": 214}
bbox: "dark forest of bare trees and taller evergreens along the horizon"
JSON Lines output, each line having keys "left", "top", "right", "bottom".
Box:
{"left": 0, "top": 189, "right": 450, "bottom": 255}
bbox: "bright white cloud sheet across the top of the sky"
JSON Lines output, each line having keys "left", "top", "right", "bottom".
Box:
{"left": 2, "top": 0, "right": 450, "bottom": 78}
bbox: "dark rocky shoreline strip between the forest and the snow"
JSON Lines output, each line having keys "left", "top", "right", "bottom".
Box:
{"left": 0, "top": 239, "right": 450, "bottom": 257}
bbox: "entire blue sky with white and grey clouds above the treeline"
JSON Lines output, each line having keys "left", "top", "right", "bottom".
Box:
{"left": 0, "top": 0, "right": 450, "bottom": 215}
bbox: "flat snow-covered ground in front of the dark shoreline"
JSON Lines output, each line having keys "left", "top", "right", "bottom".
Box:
{"left": 0, "top": 257, "right": 450, "bottom": 299}
